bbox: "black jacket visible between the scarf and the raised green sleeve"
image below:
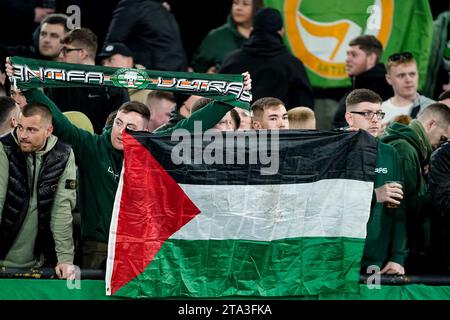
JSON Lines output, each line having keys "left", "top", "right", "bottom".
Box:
{"left": 46, "top": 87, "right": 130, "bottom": 134}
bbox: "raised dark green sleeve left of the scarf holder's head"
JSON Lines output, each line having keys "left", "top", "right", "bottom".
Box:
{"left": 24, "top": 89, "right": 95, "bottom": 164}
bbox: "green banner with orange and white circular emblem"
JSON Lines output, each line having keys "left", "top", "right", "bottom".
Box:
{"left": 265, "top": 0, "right": 433, "bottom": 90}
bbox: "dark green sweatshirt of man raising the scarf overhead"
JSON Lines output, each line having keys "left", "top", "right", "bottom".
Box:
{"left": 25, "top": 89, "right": 233, "bottom": 243}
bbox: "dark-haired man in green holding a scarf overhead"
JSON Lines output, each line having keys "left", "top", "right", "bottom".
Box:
{"left": 6, "top": 58, "right": 251, "bottom": 268}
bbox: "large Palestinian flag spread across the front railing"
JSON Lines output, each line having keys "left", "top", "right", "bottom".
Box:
{"left": 106, "top": 130, "right": 377, "bottom": 298}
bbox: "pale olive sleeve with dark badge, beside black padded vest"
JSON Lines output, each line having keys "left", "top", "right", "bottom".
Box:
{"left": 50, "top": 150, "right": 76, "bottom": 264}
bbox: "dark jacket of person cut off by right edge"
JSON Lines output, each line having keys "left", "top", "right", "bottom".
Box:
{"left": 430, "top": 141, "right": 450, "bottom": 274}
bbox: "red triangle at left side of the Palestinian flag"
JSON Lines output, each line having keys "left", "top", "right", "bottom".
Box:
{"left": 110, "top": 132, "right": 200, "bottom": 294}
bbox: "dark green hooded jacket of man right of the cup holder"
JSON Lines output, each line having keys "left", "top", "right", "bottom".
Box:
{"left": 382, "top": 120, "right": 432, "bottom": 252}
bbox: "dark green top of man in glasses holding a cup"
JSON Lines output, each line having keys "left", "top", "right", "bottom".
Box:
{"left": 362, "top": 142, "right": 407, "bottom": 269}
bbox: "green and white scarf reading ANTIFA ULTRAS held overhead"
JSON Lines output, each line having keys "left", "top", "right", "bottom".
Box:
{"left": 11, "top": 57, "right": 252, "bottom": 110}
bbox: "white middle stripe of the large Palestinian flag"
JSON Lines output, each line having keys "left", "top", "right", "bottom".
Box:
{"left": 170, "top": 179, "right": 373, "bottom": 241}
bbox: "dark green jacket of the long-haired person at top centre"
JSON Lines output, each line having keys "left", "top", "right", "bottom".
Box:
{"left": 191, "top": 16, "right": 247, "bottom": 72}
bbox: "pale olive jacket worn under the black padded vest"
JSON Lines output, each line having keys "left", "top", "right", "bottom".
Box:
{"left": 0, "top": 135, "right": 76, "bottom": 268}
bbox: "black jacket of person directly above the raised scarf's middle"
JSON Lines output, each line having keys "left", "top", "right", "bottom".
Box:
{"left": 105, "top": 0, "right": 187, "bottom": 71}
